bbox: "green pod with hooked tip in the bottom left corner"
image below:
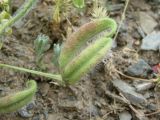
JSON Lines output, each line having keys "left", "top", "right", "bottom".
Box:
{"left": 0, "top": 80, "right": 37, "bottom": 113}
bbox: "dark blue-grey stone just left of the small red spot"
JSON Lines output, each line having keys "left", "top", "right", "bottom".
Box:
{"left": 126, "top": 59, "right": 152, "bottom": 77}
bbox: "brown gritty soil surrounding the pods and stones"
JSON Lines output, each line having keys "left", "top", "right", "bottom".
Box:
{"left": 0, "top": 0, "right": 160, "bottom": 120}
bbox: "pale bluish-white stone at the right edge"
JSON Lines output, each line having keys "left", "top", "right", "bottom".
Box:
{"left": 141, "top": 32, "right": 160, "bottom": 51}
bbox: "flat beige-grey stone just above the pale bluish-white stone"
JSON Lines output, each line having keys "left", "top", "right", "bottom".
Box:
{"left": 139, "top": 12, "right": 158, "bottom": 34}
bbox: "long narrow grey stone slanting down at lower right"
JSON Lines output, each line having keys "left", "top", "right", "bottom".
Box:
{"left": 112, "top": 80, "right": 147, "bottom": 106}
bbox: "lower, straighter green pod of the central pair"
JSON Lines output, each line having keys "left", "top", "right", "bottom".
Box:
{"left": 63, "top": 38, "right": 112, "bottom": 84}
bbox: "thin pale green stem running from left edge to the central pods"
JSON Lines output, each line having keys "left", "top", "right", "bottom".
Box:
{"left": 0, "top": 64, "right": 63, "bottom": 84}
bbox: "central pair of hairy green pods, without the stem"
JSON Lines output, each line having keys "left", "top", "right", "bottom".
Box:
{"left": 59, "top": 18, "right": 117, "bottom": 84}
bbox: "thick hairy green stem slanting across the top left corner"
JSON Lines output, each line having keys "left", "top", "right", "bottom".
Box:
{"left": 0, "top": 0, "right": 37, "bottom": 35}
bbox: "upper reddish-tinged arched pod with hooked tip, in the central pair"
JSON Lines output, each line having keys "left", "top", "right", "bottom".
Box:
{"left": 59, "top": 18, "right": 117, "bottom": 69}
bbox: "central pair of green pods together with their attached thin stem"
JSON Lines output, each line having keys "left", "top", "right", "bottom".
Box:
{"left": 0, "top": 17, "right": 117, "bottom": 112}
